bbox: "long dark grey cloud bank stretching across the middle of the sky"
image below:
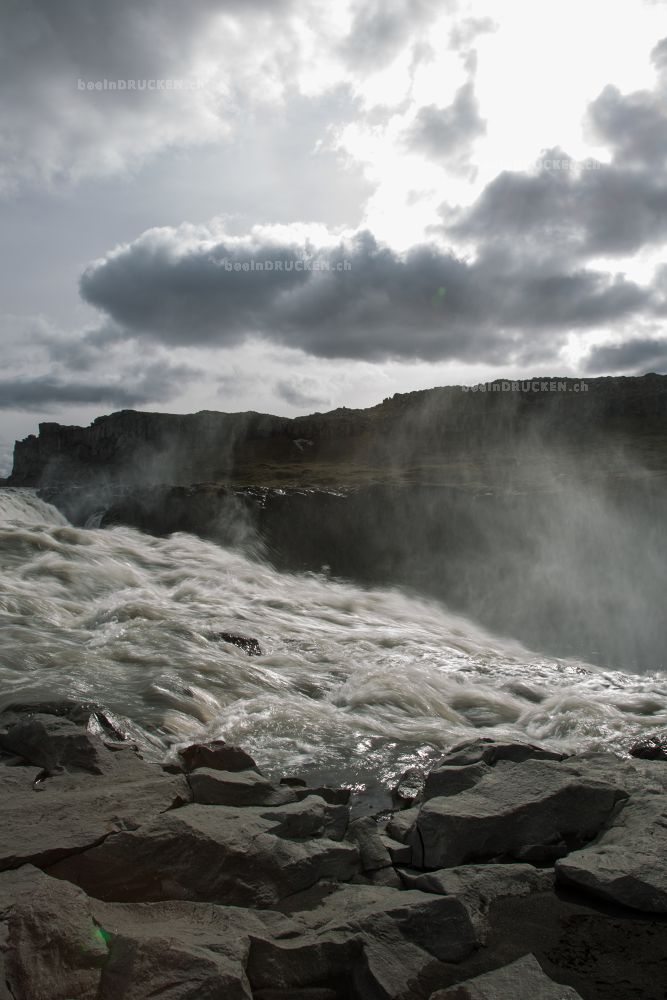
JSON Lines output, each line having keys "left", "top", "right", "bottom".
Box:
{"left": 81, "top": 230, "right": 651, "bottom": 363}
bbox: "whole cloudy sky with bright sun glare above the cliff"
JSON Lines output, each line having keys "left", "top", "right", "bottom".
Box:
{"left": 0, "top": 0, "right": 667, "bottom": 466}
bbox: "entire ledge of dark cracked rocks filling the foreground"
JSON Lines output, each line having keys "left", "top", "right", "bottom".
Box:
{"left": 0, "top": 703, "right": 667, "bottom": 1000}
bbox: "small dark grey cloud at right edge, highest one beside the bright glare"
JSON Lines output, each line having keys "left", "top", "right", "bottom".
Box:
{"left": 588, "top": 38, "right": 667, "bottom": 167}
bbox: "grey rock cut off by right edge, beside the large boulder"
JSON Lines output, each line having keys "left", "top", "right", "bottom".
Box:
{"left": 556, "top": 793, "right": 667, "bottom": 913}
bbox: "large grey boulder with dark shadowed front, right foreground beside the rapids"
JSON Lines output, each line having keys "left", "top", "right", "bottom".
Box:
{"left": 410, "top": 758, "right": 627, "bottom": 868}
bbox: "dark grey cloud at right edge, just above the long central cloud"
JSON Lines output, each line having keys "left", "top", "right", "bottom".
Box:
{"left": 447, "top": 149, "right": 667, "bottom": 258}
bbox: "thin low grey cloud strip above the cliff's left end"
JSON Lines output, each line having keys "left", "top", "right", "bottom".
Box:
{"left": 0, "top": 363, "right": 197, "bottom": 410}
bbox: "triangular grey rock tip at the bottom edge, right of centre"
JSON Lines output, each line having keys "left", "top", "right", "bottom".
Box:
{"left": 431, "top": 955, "right": 581, "bottom": 1000}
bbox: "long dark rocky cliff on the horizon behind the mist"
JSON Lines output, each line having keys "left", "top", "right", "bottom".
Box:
{"left": 8, "top": 375, "right": 667, "bottom": 486}
